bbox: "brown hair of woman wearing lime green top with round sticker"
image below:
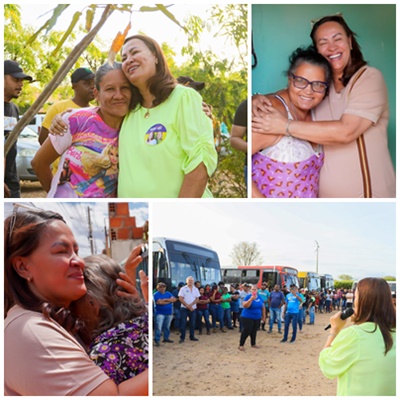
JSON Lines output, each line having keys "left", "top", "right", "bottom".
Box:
{"left": 124, "top": 35, "right": 177, "bottom": 109}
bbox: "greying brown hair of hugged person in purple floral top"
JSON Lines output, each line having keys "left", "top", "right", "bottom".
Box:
{"left": 80, "top": 255, "right": 147, "bottom": 339}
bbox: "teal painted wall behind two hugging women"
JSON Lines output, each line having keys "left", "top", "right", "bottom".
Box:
{"left": 252, "top": 4, "right": 396, "bottom": 166}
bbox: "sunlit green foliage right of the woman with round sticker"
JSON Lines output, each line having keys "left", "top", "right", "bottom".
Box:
{"left": 177, "top": 4, "right": 248, "bottom": 197}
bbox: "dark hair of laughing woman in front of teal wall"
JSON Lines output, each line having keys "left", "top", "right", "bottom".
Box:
{"left": 310, "top": 15, "right": 367, "bottom": 86}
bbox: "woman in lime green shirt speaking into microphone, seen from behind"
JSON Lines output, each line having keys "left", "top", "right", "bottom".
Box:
{"left": 319, "top": 278, "right": 396, "bottom": 396}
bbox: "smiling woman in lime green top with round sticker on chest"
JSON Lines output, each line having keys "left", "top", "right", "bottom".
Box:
{"left": 118, "top": 35, "right": 217, "bottom": 198}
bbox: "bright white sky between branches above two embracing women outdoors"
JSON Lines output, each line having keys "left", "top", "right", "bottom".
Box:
{"left": 16, "top": 3, "right": 244, "bottom": 65}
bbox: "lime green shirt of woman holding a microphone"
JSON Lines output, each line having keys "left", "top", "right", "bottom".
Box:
{"left": 319, "top": 322, "right": 396, "bottom": 396}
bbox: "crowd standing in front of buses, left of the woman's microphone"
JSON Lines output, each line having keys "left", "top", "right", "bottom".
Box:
{"left": 154, "top": 276, "right": 319, "bottom": 350}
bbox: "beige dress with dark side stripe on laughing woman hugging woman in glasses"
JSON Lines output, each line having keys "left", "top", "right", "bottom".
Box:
{"left": 315, "top": 67, "right": 396, "bottom": 198}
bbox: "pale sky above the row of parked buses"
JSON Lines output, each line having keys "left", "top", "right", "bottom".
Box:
{"left": 152, "top": 201, "right": 396, "bottom": 279}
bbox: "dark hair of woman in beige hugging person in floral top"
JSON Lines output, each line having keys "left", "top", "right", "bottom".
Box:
{"left": 4, "top": 209, "right": 81, "bottom": 334}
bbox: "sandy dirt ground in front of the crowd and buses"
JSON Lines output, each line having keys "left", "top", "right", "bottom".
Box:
{"left": 153, "top": 314, "right": 336, "bottom": 396}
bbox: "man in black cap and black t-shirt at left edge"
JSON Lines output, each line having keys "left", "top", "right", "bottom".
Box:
{"left": 4, "top": 60, "right": 32, "bottom": 197}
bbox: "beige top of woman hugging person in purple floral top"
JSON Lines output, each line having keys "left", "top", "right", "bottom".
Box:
{"left": 4, "top": 306, "right": 108, "bottom": 396}
